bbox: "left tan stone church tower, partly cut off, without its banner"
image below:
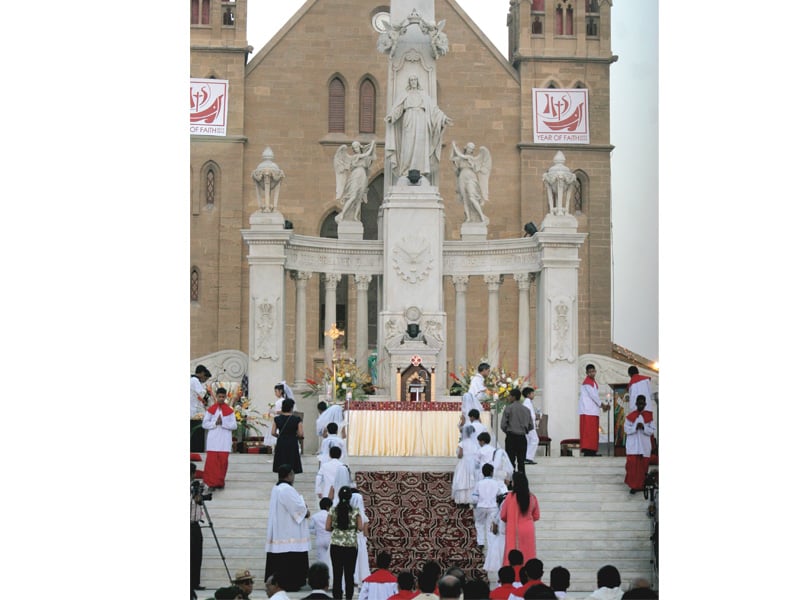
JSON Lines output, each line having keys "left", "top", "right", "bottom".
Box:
{"left": 190, "top": 0, "right": 252, "bottom": 355}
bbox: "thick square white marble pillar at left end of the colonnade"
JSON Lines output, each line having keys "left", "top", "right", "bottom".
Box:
{"left": 242, "top": 211, "right": 292, "bottom": 412}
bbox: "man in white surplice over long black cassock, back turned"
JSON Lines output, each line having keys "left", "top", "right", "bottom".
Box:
{"left": 264, "top": 465, "right": 311, "bottom": 592}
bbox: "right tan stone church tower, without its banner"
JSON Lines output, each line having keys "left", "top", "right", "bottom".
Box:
{"left": 507, "top": 0, "right": 617, "bottom": 355}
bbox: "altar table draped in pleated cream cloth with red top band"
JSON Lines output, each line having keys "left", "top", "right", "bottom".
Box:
{"left": 347, "top": 400, "right": 491, "bottom": 458}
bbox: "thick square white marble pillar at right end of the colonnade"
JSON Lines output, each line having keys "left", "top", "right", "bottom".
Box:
{"left": 534, "top": 214, "right": 588, "bottom": 451}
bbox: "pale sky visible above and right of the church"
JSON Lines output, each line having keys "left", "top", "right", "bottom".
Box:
{"left": 247, "top": 0, "right": 659, "bottom": 361}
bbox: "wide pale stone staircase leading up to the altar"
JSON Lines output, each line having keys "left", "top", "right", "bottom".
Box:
{"left": 198, "top": 454, "right": 658, "bottom": 598}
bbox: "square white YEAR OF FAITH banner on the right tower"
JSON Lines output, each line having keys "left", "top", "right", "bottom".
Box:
{"left": 533, "top": 88, "right": 589, "bottom": 144}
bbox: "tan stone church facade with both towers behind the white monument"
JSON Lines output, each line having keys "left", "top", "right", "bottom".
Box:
{"left": 189, "top": 0, "right": 616, "bottom": 390}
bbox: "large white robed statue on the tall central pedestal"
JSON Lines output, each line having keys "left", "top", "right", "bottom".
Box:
{"left": 385, "top": 75, "right": 453, "bottom": 184}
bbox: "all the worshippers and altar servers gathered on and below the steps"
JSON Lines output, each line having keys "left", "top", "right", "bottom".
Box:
{"left": 191, "top": 363, "right": 658, "bottom": 600}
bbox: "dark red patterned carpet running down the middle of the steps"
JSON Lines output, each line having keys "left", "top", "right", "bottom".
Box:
{"left": 356, "top": 471, "right": 486, "bottom": 579}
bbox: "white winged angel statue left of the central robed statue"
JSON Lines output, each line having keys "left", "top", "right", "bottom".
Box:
{"left": 333, "top": 140, "right": 375, "bottom": 223}
